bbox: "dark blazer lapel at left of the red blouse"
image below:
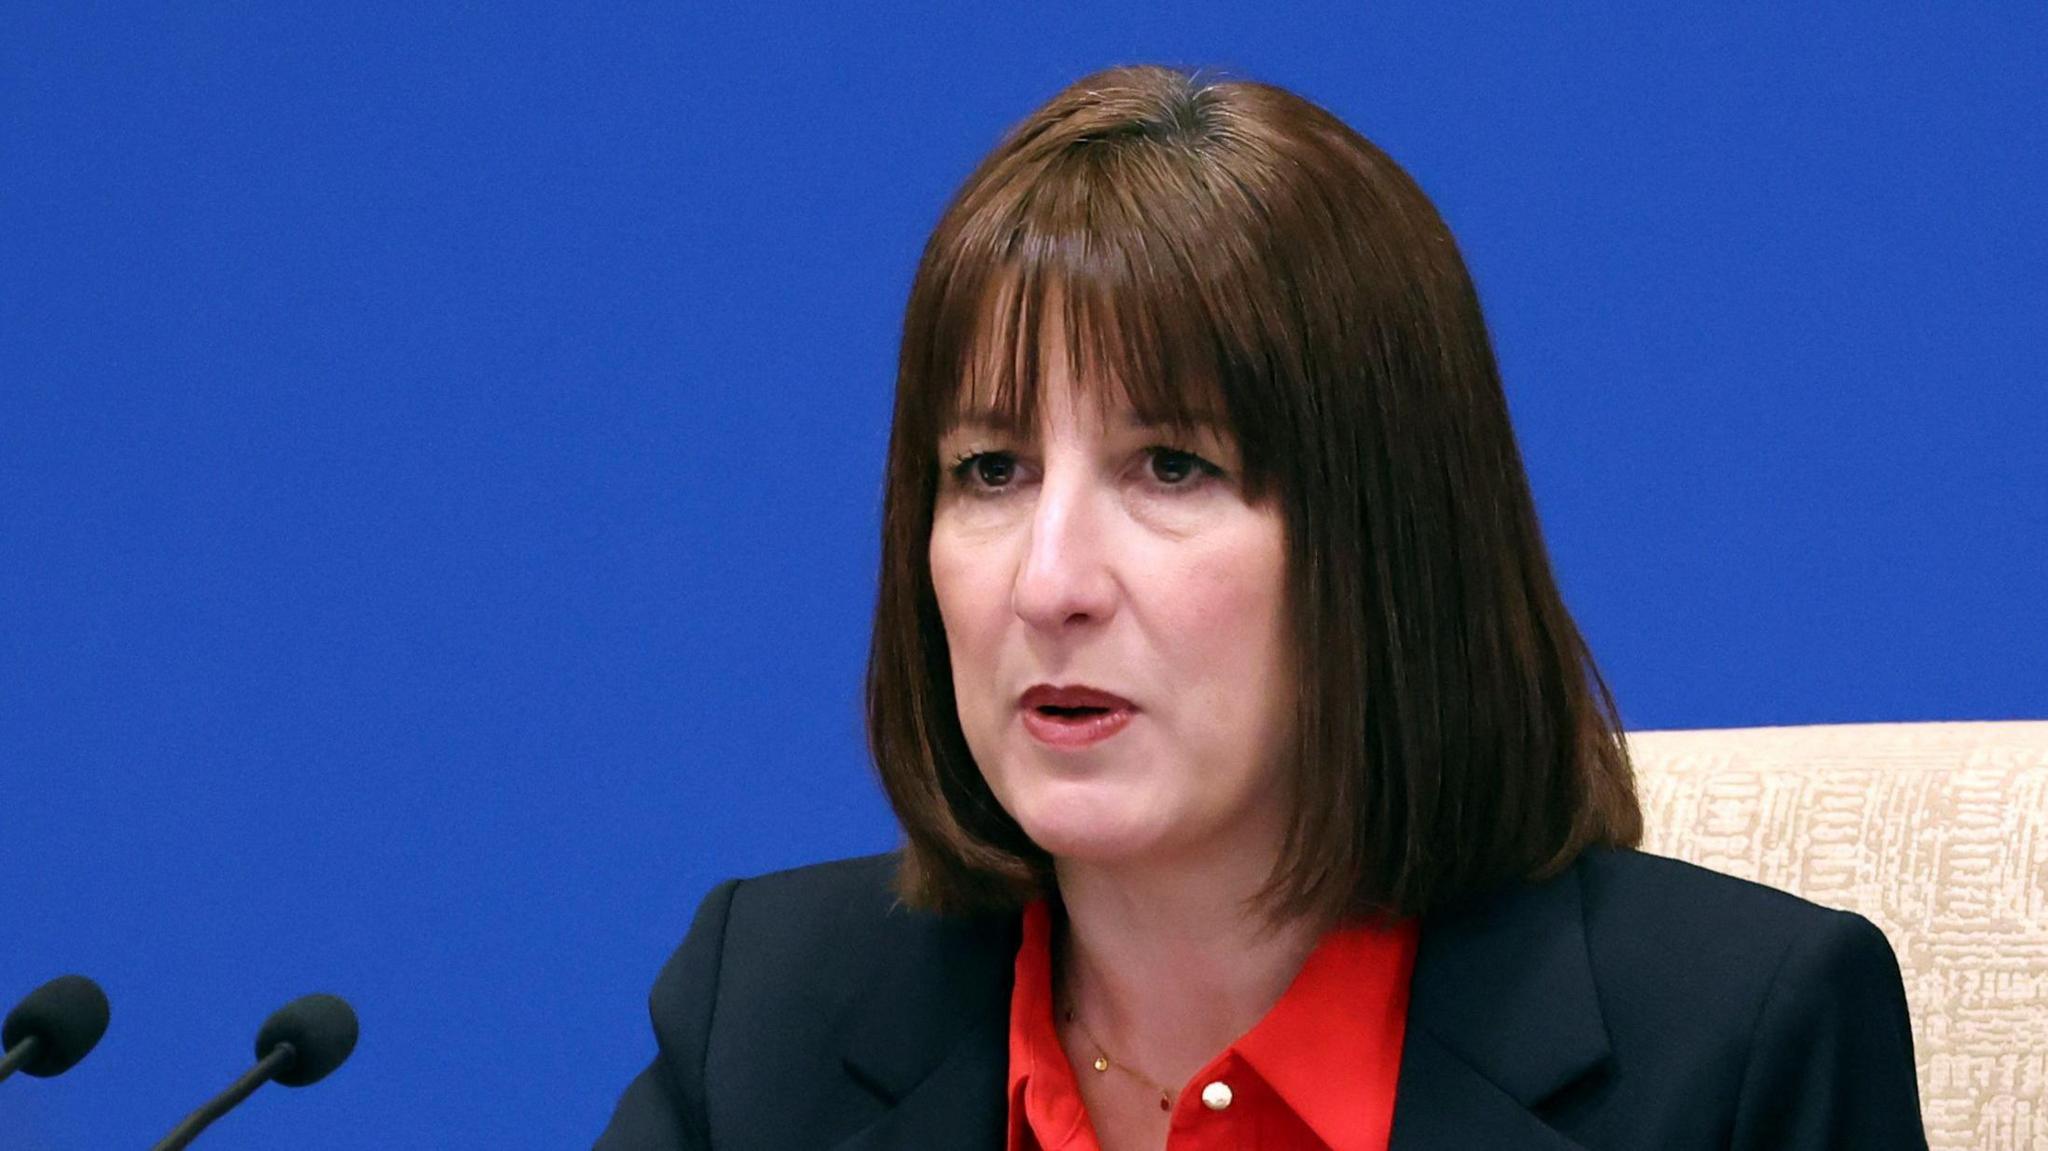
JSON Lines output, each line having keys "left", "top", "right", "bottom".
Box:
{"left": 825, "top": 915, "right": 1020, "bottom": 1151}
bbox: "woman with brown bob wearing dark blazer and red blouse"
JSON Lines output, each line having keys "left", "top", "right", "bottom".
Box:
{"left": 598, "top": 68, "right": 1925, "bottom": 1151}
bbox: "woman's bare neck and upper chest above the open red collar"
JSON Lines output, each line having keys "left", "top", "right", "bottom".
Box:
{"left": 1055, "top": 839, "right": 1319, "bottom": 1088}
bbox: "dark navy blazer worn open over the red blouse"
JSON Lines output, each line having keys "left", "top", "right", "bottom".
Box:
{"left": 598, "top": 850, "right": 1927, "bottom": 1151}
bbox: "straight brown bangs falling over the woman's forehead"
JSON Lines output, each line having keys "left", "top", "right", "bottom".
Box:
{"left": 901, "top": 143, "right": 1286, "bottom": 500}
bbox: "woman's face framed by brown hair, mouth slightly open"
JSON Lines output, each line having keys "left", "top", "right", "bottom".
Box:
{"left": 930, "top": 332, "right": 1294, "bottom": 864}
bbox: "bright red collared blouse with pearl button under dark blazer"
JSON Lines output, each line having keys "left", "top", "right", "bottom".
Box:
{"left": 1008, "top": 899, "right": 1417, "bottom": 1151}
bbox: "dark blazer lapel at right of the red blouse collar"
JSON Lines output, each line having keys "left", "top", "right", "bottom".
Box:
{"left": 1391, "top": 856, "right": 1610, "bottom": 1151}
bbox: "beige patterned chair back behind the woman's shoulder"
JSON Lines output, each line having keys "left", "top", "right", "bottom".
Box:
{"left": 1628, "top": 721, "right": 2048, "bottom": 1151}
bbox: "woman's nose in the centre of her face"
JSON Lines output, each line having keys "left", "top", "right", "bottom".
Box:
{"left": 1012, "top": 460, "right": 1116, "bottom": 631}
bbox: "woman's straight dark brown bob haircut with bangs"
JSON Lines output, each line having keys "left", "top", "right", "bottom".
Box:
{"left": 866, "top": 66, "right": 1642, "bottom": 922}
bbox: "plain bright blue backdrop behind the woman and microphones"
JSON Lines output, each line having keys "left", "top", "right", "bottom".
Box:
{"left": 0, "top": 0, "right": 2048, "bottom": 1151}
